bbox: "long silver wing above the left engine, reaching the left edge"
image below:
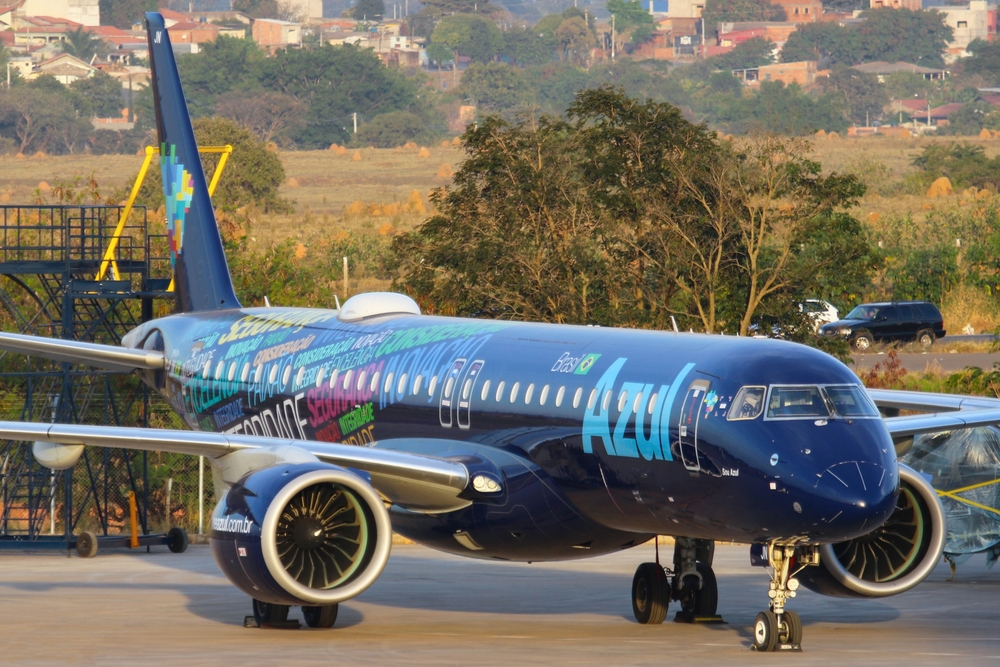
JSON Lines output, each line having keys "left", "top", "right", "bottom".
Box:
{"left": 0, "top": 421, "right": 470, "bottom": 513}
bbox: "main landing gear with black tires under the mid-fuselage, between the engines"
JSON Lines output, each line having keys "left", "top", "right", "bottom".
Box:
{"left": 632, "top": 537, "right": 722, "bottom": 624}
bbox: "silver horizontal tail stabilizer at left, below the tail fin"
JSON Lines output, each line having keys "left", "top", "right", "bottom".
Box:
{"left": 0, "top": 332, "right": 166, "bottom": 373}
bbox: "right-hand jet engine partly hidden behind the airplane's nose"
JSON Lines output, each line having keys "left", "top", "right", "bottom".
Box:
{"left": 796, "top": 465, "right": 947, "bottom": 597}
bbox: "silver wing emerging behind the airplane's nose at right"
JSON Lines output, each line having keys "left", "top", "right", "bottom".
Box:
{"left": 868, "top": 389, "right": 1000, "bottom": 456}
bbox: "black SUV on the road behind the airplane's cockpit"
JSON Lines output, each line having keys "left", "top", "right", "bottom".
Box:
{"left": 819, "top": 301, "right": 945, "bottom": 351}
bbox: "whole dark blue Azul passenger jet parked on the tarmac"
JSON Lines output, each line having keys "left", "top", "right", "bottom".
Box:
{"left": 0, "top": 13, "right": 1000, "bottom": 651}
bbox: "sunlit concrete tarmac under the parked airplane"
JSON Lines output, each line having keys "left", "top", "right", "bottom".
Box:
{"left": 0, "top": 545, "right": 1000, "bottom": 667}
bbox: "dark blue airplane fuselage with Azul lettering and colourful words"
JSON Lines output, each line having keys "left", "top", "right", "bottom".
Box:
{"left": 125, "top": 308, "right": 899, "bottom": 560}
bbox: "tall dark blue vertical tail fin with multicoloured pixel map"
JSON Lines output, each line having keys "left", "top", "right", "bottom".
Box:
{"left": 146, "top": 12, "right": 240, "bottom": 313}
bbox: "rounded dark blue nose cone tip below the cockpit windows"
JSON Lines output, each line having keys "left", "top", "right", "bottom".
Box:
{"left": 815, "top": 461, "right": 899, "bottom": 540}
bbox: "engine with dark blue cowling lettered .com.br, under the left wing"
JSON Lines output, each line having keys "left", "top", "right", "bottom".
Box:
{"left": 211, "top": 462, "right": 392, "bottom": 606}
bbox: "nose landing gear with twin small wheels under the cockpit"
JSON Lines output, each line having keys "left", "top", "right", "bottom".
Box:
{"left": 753, "top": 542, "right": 819, "bottom": 652}
